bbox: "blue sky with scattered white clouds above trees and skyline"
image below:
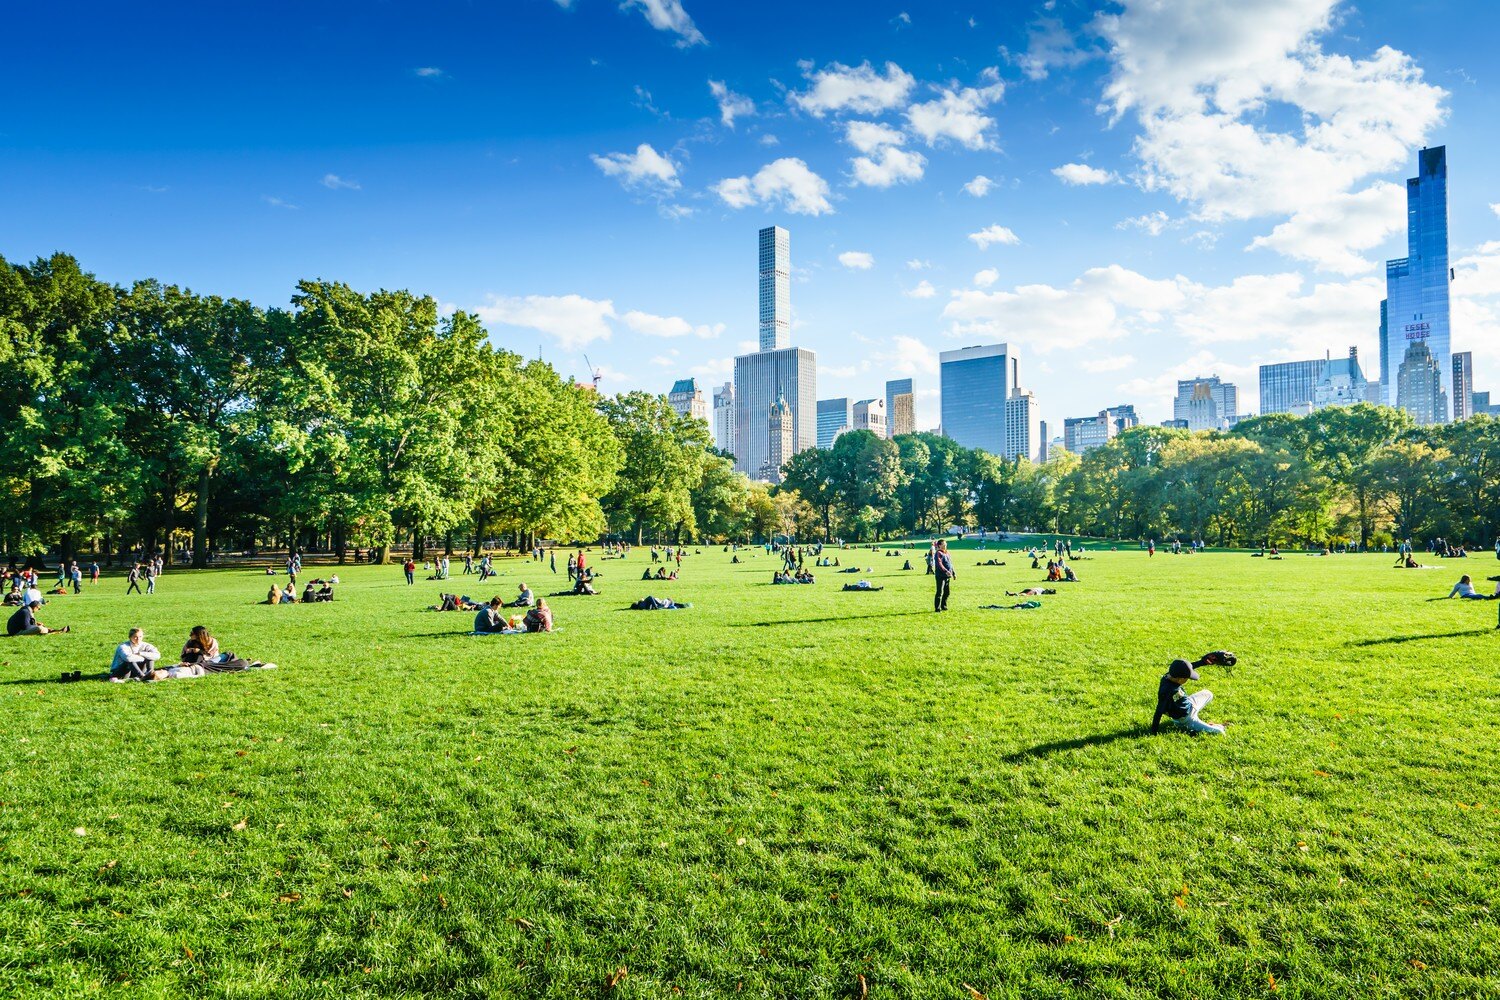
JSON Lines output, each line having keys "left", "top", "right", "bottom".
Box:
{"left": 0, "top": 0, "right": 1500, "bottom": 427}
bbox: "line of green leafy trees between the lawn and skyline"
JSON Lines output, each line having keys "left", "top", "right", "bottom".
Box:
{"left": 0, "top": 253, "right": 1500, "bottom": 565}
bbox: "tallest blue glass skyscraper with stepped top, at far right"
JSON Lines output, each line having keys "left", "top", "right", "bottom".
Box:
{"left": 1380, "top": 145, "right": 1455, "bottom": 423}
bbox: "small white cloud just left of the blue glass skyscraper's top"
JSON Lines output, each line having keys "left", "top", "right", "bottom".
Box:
{"left": 1247, "top": 181, "right": 1406, "bottom": 274}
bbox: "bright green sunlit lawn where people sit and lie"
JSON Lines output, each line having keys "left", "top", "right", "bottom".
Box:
{"left": 0, "top": 546, "right": 1500, "bottom": 1000}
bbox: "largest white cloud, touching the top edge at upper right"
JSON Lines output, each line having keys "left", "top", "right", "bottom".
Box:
{"left": 1095, "top": 0, "right": 1448, "bottom": 273}
